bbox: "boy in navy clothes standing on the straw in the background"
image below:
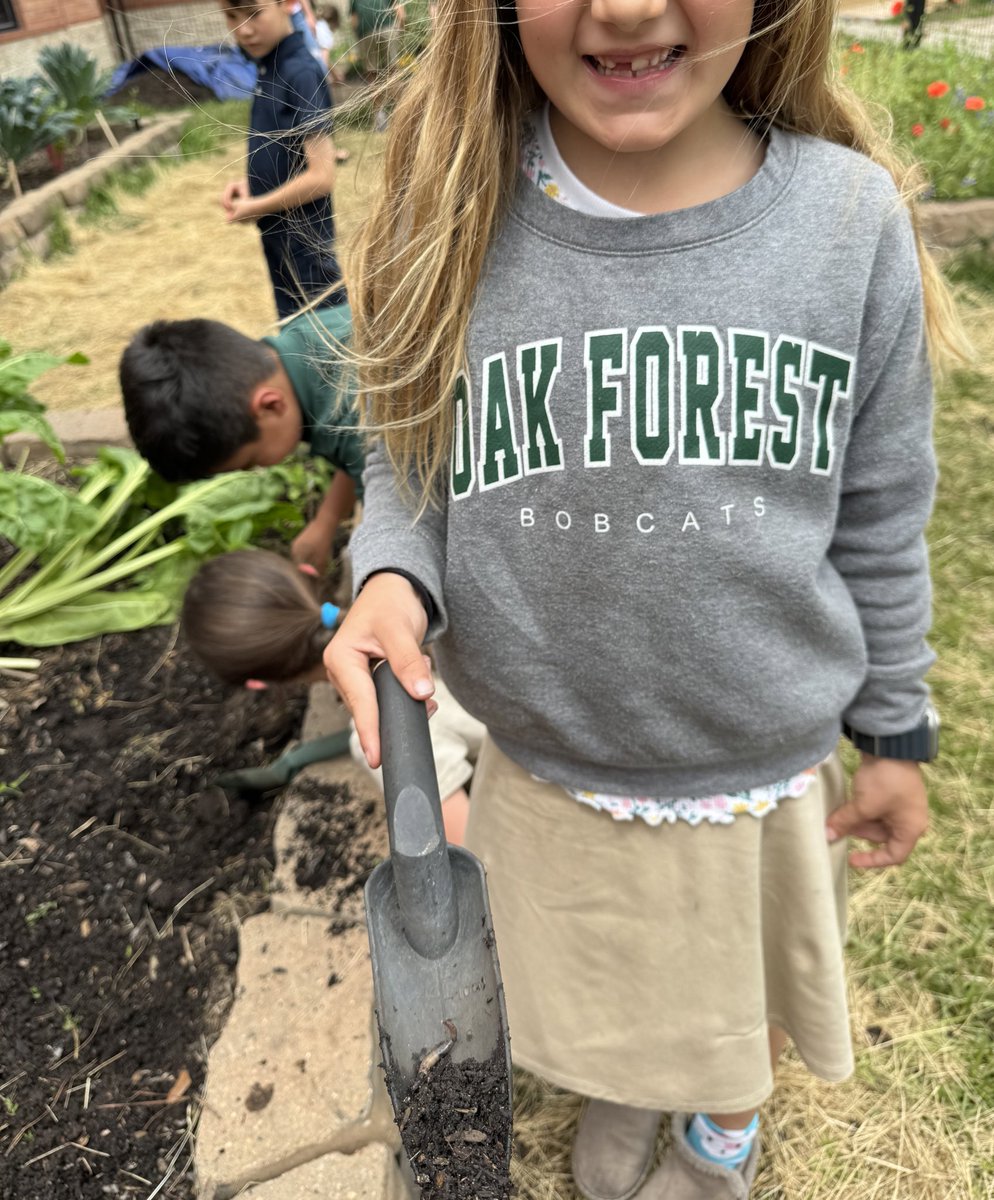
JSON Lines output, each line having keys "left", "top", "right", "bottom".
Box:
{"left": 221, "top": 0, "right": 345, "bottom": 319}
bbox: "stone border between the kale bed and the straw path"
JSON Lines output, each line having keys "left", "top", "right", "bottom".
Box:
{"left": 0, "top": 115, "right": 186, "bottom": 287}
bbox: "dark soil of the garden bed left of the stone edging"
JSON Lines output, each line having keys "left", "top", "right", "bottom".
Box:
{"left": 0, "top": 629, "right": 306, "bottom": 1200}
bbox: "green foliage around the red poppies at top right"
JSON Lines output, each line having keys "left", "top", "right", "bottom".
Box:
{"left": 839, "top": 38, "right": 994, "bottom": 200}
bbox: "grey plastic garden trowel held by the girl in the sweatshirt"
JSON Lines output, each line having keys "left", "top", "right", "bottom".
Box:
{"left": 366, "top": 661, "right": 511, "bottom": 1169}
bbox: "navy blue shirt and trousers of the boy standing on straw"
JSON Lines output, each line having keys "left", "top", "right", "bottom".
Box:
{"left": 249, "top": 32, "right": 341, "bottom": 316}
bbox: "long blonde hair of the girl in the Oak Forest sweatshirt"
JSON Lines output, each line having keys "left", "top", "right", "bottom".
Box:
{"left": 348, "top": 0, "right": 963, "bottom": 505}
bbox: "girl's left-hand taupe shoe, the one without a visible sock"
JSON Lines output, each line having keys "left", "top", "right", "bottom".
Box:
{"left": 573, "top": 1100, "right": 663, "bottom": 1200}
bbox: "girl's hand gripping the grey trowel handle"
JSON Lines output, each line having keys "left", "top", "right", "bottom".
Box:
{"left": 324, "top": 571, "right": 435, "bottom": 769}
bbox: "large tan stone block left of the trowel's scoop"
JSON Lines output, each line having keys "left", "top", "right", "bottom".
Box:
{"left": 196, "top": 913, "right": 397, "bottom": 1200}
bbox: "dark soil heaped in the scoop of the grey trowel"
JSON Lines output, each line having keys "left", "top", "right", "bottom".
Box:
{"left": 397, "top": 1046, "right": 511, "bottom": 1200}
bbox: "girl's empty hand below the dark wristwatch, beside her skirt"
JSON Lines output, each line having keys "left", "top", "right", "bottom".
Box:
{"left": 827, "top": 754, "right": 928, "bottom": 866}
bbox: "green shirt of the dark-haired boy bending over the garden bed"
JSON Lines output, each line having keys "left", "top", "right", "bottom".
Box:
{"left": 263, "top": 304, "right": 365, "bottom": 497}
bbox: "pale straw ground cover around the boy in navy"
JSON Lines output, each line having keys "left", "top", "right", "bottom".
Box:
{"left": 0, "top": 131, "right": 379, "bottom": 412}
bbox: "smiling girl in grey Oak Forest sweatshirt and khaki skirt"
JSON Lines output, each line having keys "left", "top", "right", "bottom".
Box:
{"left": 325, "top": 0, "right": 956, "bottom": 1200}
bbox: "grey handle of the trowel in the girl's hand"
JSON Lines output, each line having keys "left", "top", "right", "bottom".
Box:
{"left": 373, "top": 661, "right": 459, "bottom": 959}
